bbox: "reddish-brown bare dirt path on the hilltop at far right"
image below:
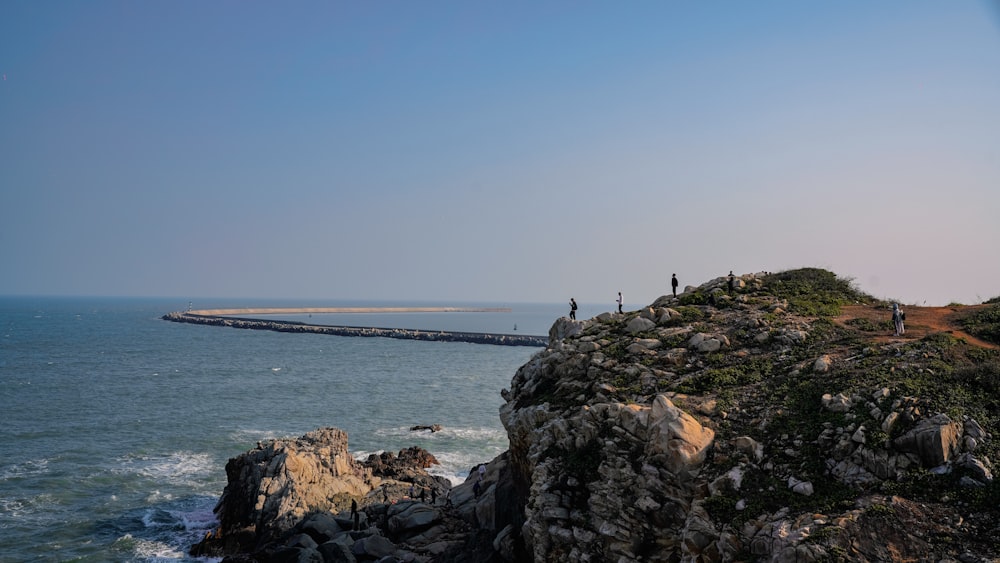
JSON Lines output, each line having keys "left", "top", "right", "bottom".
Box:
{"left": 833, "top": 305, "right": 997, "bottom": 349}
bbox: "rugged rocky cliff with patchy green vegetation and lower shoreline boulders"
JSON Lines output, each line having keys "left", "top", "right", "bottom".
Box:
{"left": 193, "top": 269, "right": 1000, "bottom": 562}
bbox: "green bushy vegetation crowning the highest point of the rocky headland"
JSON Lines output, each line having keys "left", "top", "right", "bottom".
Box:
{"left": 763, "top": 268, "right": 873, "bottom": 317}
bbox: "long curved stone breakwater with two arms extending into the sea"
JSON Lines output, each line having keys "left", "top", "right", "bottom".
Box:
{"left": 162, "top": 307, "right": 548, "bottom": 347}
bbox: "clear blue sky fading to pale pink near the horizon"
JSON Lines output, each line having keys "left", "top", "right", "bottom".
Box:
{"left": 0, "top": 0, "right": 1000, "bottom": 309}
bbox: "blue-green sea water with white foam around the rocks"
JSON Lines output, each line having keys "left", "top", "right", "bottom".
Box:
{"left": 0, "top": 297, "right": 580, "bottom": 562}
